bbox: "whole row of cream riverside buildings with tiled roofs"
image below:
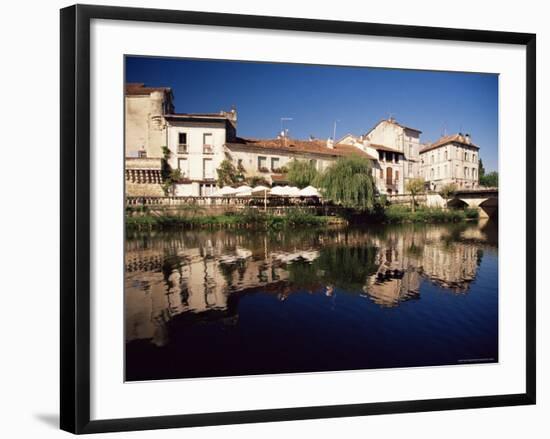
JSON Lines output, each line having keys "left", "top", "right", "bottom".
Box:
{"left": 125, "top": 84, "right": 479, "bottom": 196}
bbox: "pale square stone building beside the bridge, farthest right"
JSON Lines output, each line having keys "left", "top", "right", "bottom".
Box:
{"left": 420, "top": 133, "right": 479, "bottom": 191}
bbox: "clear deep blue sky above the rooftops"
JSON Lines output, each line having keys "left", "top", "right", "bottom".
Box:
{"left": 126, "top": 57, "right": 498, "bottom": 171}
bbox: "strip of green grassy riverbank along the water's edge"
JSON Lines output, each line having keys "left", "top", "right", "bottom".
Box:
{"left": 126, "top": 206, "right": 479, "bottom": 230}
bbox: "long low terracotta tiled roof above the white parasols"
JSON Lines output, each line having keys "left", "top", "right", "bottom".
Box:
{"left": 226, "top": 138, "right": 376, "bottom": 160}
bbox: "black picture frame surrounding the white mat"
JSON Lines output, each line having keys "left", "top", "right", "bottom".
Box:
{"left": 60, "top": 5, "right": 536, "bottom": 434}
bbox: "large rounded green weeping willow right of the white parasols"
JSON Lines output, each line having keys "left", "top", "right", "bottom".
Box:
{"left": 318, "top": 156, "right": 376, "bottom": 210}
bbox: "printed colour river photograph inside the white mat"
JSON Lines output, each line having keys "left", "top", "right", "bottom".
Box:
{"left": 124, "top": 55, "right": 499, "bottom": 381}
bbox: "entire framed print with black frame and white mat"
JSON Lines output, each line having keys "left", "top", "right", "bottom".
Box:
{"left": 61, "top": 5, "right": 536, "bottom": 433}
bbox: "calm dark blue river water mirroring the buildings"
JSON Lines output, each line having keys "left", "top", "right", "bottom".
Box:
{"left": 125, "top": 222, "right": 498, "bottom": 381}
